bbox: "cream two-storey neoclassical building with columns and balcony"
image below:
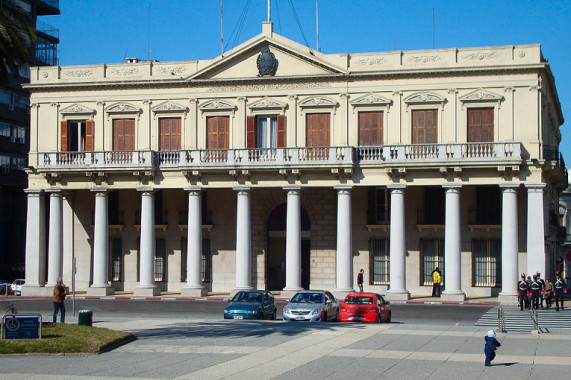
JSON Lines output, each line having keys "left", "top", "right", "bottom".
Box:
{"left": 23, "top": 22, "right": 567, "bottom": 302}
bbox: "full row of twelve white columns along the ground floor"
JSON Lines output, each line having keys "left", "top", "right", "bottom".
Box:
{"left": 23, "top": 185, "right": 545, "bottom": 300}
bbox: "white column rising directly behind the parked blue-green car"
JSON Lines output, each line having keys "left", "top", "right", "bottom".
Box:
{"left": 233, "top": 187, "right": 252, "bottom": 293}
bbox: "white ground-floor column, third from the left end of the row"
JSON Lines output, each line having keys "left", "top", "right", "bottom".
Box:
{"left": 87, "top": 189, "right": 113, "bottom": 296}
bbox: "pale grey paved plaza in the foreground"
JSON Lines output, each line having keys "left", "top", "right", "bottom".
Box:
{"left": 0, "top": 312, "right": 571, "bottom": 380}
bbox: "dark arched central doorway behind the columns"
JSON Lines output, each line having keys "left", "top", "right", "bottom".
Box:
{"left": 266, "top": 203, "right": 311, "bottom": 290}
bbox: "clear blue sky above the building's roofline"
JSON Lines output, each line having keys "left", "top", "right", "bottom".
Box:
{"left": 42, "top": 0, "right": 571, "bottom": 164}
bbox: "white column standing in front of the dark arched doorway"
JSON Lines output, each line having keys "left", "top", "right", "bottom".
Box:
{"left": 282, "top": 186, "right": 302, "bottom": 298}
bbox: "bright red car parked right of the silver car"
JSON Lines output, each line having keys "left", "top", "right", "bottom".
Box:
{"left": 339, "top": 293, "right": 391, "bottom": 323}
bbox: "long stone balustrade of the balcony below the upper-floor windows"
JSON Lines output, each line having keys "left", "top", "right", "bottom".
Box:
{"left": 38, "top": 143, "right": 521, "bottom": 170}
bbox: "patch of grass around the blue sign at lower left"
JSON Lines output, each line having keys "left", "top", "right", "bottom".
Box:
{"left": 0, "top": 323, "right": 135, "bottom": 354}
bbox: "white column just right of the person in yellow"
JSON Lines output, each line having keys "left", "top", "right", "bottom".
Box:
{"left": 442, "top": 186, "right": 466, "bottom": 301}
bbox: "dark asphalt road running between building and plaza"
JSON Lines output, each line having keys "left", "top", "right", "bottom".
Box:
{"left": 0, "top": 298, "right": 490, "bottom": 326}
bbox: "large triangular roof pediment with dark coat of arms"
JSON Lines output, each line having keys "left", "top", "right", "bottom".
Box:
{"left": 188, "top": 34, "right": 347, "bottom": 80}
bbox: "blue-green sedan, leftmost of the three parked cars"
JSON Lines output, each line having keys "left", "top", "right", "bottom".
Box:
{"left": 224, "top": 290, "right": 277, "bottom": 319}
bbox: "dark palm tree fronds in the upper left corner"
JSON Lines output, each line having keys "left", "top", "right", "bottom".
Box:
{"left": 0, "top": 0, "right": 36, "bottom": 86}
